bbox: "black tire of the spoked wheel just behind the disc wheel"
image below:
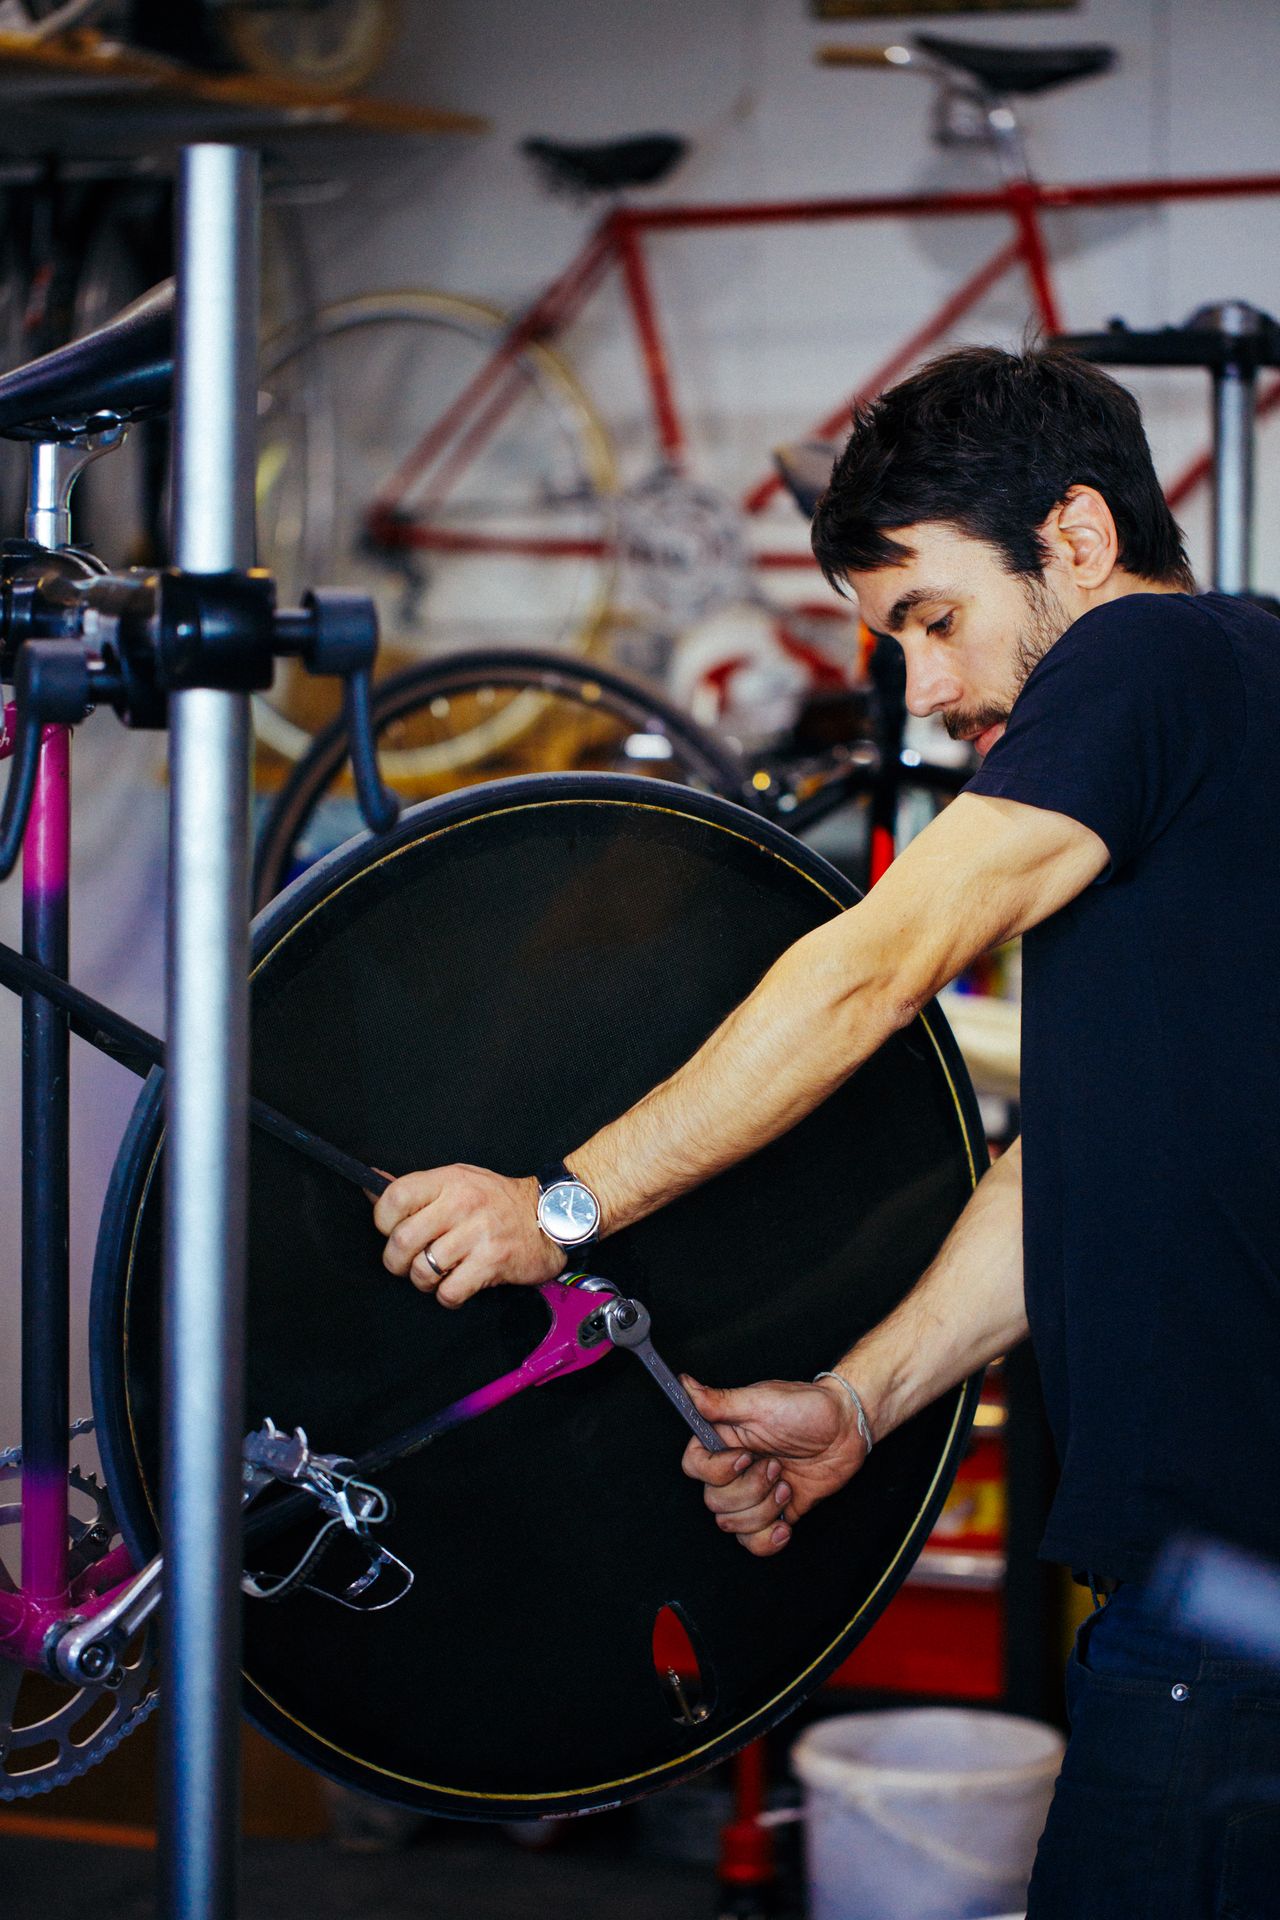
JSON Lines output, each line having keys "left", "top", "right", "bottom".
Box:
{"left": 253, "top": 649, "right": 754, "bottom": 912}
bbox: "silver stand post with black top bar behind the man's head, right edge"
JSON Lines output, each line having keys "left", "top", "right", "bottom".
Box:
{"left": 1055, "top": 300, "right": 1280, "bottom": 595}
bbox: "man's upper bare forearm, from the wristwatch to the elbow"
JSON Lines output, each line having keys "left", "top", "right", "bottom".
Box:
{"left": 568, "top": 908, "right": 912, "bottom": 1233}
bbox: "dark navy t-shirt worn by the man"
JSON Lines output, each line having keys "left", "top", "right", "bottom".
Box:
{"left": 967, "top": 593, "right": 1280, "bottom": 1578}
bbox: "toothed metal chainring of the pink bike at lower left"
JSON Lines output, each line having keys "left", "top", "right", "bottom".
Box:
{"left": 0, "top": 1455, "right": 159, "bottom": 1803}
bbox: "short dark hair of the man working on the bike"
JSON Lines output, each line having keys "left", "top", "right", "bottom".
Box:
{"left": 814, "top": 348, "right": 1194, "bottom": 589}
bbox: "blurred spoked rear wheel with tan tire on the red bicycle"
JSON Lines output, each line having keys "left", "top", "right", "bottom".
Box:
{"left": 255, "top": 288, "right": 616, "bottom": 780}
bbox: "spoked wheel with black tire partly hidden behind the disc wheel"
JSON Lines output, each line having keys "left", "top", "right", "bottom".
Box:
{"left": 253, "top": 647, "right": 752, "bottom": 908}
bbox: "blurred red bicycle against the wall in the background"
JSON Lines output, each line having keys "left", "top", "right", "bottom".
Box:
{"left": 259, "top": 35, "right": 1280, "bottom": 791}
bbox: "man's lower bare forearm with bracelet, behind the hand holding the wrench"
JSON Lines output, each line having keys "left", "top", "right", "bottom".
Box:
{"left": 835, "top": 1140, "right": 1027, "bottom": 1440}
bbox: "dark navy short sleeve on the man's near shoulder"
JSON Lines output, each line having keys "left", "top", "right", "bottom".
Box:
{"left": 965, "top": 593, "right": 1244, "bottom": 879}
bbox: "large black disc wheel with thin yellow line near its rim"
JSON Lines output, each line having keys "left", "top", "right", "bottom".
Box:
{"left": 92, "top": 774, "right": 984, "bottom": 1820}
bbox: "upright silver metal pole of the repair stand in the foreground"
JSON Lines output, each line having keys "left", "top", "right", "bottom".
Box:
{"left": 159, "top": 146, "right": 259, "bottom": 1920}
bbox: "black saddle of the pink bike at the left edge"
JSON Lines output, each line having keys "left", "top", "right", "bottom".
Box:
{"left": 0, "top": 280, "right": 173, "bottom": 440}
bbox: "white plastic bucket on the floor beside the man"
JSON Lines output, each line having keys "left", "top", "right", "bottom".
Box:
{"left": 791, "top": 1707, "right": 1063, "bottom": 1920}
